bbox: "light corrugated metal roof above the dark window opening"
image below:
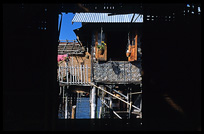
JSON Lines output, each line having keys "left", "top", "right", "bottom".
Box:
{"left": 72, "top": 13, "right": 143, "bottom": 23}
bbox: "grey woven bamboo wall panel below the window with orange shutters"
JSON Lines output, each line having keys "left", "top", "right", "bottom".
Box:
{"left": 94, "top": 61, "right": 142, "bottom": 83}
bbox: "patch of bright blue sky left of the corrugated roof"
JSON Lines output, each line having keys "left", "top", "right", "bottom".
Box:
{"left": 58, "top": 13, "right": 81, "bottom": 40}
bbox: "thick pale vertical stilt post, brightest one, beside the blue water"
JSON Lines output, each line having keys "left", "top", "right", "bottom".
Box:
{"left": 91, "top": 87, "right": 96, "bottom": 119}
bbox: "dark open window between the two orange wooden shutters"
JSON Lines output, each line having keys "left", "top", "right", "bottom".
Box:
{"left": 107, "top": 31, "right": 128, "bottom": 61}
